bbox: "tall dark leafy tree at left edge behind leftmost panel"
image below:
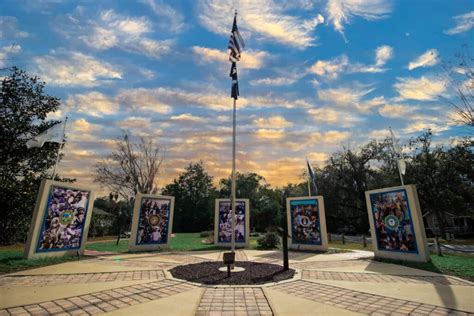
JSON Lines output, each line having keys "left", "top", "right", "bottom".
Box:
{"left": 0, "top": 67, "right": 72, "bottom": 243}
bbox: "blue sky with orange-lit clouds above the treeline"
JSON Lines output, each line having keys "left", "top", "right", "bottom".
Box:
{"left": 0, "top": 0, "right": 474, "bottom": 192}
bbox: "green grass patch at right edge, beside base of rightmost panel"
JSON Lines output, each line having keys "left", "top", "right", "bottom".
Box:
{"left": 376, "top": 254, "right": 474, "bottom": 281}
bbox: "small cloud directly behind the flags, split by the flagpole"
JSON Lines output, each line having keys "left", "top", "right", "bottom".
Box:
{"left": 192, "top": 46, "right": 270, "bottom": 69}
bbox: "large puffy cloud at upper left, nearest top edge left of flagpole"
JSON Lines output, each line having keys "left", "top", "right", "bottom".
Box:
{"left": 57, "top": 7, "right": 173, "bottom": 58}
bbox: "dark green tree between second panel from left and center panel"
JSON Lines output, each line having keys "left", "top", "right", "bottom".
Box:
{"left": 163, "top": 161, "right": 217, "bottom": 232}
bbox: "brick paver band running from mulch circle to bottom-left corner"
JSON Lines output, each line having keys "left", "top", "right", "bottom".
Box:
{"left": 0, "top": 280, "right": 196, "bottom": 315}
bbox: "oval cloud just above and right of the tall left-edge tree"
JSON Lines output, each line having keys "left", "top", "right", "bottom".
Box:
{"left": 33, "top": 51, "right": 122, "bottom": 87}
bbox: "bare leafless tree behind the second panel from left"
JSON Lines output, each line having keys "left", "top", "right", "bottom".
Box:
{"left": 95, "top": 133, "right": 164, "bottom": 201}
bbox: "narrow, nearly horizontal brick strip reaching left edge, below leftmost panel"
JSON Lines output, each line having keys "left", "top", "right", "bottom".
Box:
{"left": 0, "top": 270, "right": 165, "bottom": 287}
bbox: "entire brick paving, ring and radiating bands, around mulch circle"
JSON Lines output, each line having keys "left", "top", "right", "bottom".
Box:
{"left": 0, "top": 250, "right": 474, "bottom": 316}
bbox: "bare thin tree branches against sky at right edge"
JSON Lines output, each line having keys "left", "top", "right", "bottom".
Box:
{"left": 441, "top": 45, "right": 474, "bottom": 127}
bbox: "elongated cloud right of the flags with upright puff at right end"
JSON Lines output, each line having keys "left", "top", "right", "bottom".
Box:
{"left": 308, "top": 45, "right": 393, "bottom": 80}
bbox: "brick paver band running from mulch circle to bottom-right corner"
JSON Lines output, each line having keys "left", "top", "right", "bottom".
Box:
{"left": 272, "top": 280, "right": 469, "bottom": 315}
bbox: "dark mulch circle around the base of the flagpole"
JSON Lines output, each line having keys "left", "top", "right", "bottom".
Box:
{"left": 169, "top": 261, "right": 295, "bottom": 285}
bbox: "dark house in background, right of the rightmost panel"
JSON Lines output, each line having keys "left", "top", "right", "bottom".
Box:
{"left": 423, "top": 211, "right": 474, "bottom": 237}
